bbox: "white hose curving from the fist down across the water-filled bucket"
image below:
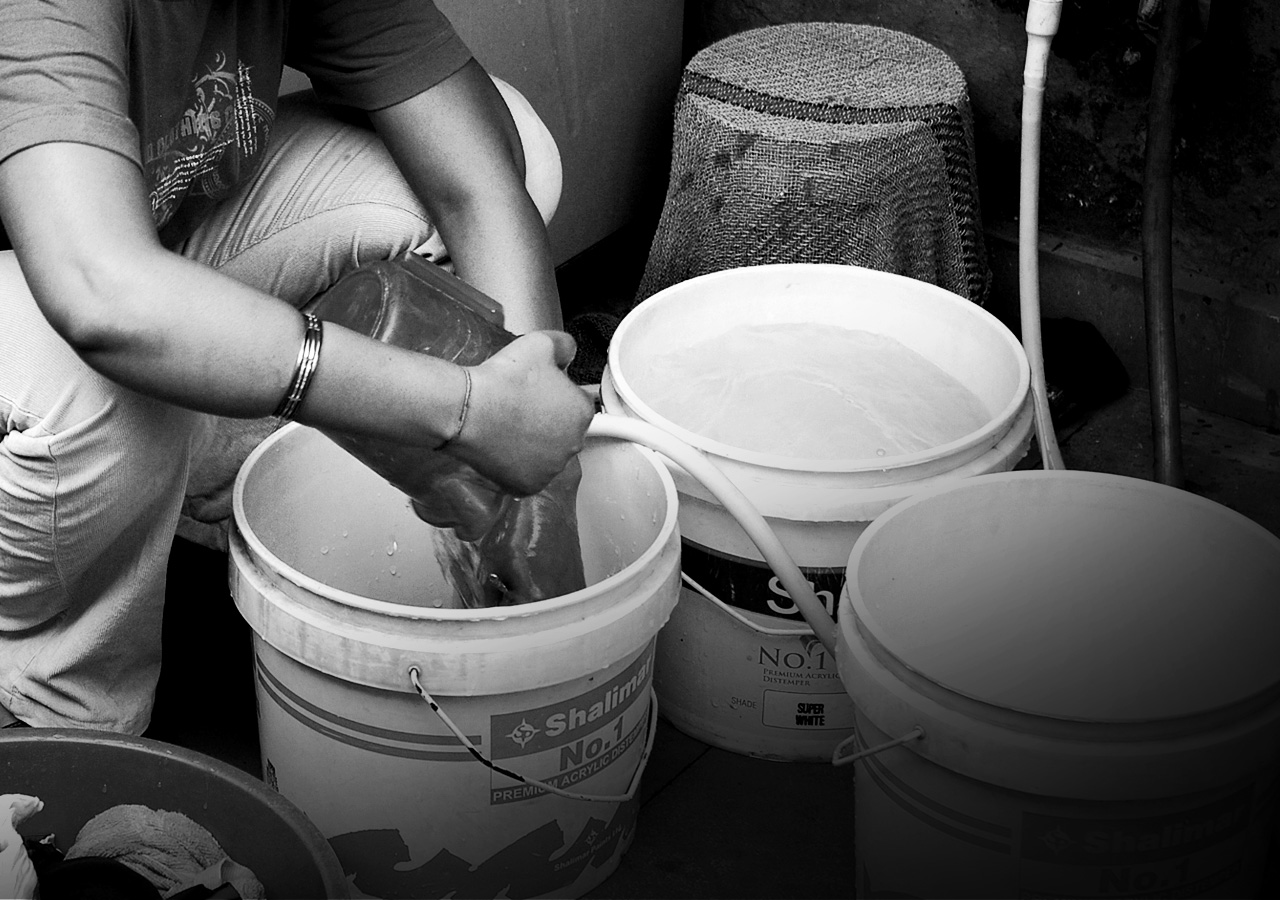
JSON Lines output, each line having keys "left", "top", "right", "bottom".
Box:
{"left": 586, "top": 414, "right": 836, "bottom": 654}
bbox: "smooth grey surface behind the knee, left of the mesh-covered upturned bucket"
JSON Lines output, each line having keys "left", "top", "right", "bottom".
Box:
{"left": 282, "top": 0, "right": 685, "bottom": 264}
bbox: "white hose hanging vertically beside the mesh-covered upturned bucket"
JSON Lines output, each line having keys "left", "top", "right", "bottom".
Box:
{"left": 1018, "top": 0, "right": 1066, "bottom": 469}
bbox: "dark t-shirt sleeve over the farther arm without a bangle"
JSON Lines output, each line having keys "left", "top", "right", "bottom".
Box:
{"left": 285, "top": 0, "right": 471, "bottom": 110}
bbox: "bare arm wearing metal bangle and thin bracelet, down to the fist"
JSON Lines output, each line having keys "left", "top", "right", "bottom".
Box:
{"left": 0, "top": 143, "right": 590, "bottom": 493}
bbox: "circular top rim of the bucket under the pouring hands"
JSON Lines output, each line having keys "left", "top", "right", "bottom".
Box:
{"left": 232, "top": 422, "right": 678, "bottom": 622}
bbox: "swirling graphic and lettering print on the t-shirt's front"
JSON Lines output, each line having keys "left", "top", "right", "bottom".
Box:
{"left": 143, "top": 52, "right": 275, "bottom": 228}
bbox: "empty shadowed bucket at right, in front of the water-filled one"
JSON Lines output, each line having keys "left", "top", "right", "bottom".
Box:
{"left": 836, "top": 471, "right": 1280, "bottom": 897}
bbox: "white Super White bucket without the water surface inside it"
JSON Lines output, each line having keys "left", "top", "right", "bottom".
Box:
{"left": 600, "top": 264, "right": 1033, "bottom": 762}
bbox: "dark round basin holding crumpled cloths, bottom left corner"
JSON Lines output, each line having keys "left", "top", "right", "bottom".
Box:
{"left": 0, "top": 728, "right": 351, "bottom": 897}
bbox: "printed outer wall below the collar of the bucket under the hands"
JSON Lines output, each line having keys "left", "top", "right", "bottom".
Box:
{"left": 256, "top": 640, "right": 655, "bottom": 897}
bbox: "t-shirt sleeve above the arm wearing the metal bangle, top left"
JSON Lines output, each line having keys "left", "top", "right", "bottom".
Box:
{"left": 0, "top": 0, "right": 141, "bottom": 170}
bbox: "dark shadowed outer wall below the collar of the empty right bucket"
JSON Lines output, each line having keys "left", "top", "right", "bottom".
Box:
{"left": 855, "top": 719, "right": 1276, "bottom": 899}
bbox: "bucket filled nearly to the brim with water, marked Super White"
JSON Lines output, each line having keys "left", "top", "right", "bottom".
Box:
{"left": 602, "top": 264, "right": 1033, "bottom": 760}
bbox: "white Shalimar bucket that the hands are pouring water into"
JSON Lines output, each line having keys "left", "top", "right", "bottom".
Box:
{"left": 230, "top": 426, "right": 680, "bottom": 897}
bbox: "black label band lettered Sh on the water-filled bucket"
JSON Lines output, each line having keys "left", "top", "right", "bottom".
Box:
{"left": 680, "top": 538, "right": 845, "bottom": 622}
